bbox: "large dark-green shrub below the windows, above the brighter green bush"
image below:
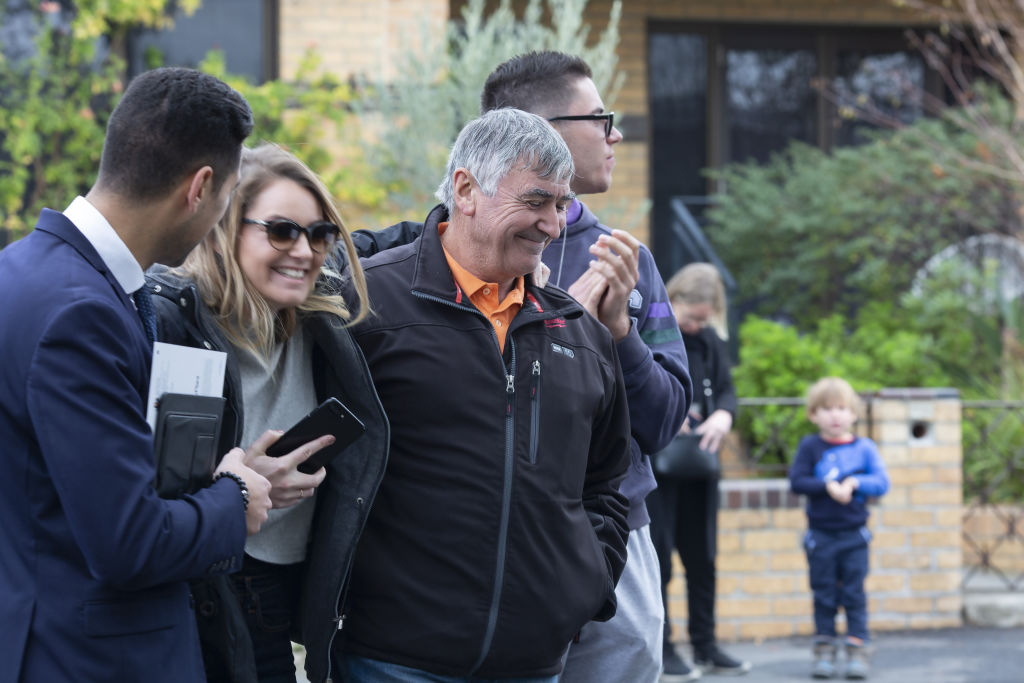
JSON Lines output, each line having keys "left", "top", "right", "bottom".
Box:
{"left": 708, "top": 95, "right": 1021, "bottom": 330}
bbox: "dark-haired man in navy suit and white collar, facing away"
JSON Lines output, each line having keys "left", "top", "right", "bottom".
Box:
{"left": 0, "top": 69, "right": 270, "bottom": 682}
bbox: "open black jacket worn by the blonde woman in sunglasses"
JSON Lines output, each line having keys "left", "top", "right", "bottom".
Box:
{"left": 146, "top": 266, "right": 390, "bottom": 681}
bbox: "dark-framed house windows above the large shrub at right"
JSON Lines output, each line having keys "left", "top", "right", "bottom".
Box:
{"left": 647, "top": 24, "right": 942, "bottom": 276}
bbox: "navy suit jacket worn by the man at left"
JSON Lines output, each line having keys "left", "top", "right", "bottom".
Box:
{"left": 0, "top": 210, "right": 246, "bottom": 683}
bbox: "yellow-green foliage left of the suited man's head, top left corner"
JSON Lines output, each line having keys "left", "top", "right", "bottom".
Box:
{"left": 0, "top": 0, "right": 199, "bottom": 237}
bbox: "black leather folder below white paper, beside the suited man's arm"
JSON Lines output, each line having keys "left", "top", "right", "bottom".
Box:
{"left": 154, "top": 393, "right": 224, "bottom": 498}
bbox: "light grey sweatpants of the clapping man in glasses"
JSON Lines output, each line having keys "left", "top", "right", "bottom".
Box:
{"left": 558, "top": 525, "right": 665, "bottom": 683}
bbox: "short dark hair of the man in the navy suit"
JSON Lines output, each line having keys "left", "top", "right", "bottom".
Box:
{"left": 97, "top": 67, "right": 253, "bottom": 200}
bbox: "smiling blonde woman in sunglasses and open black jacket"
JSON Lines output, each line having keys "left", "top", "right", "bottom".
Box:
{"left": 148, "top": 144, "right": 388, "bottom": 681}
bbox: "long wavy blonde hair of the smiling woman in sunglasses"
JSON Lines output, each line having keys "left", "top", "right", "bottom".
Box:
{"left": 175, "top": 143, "right": 370, "bottom": 358}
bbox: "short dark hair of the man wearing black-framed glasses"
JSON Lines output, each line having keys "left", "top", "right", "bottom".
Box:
{"left": 480, "top": 50, "right": 593, "bottom": 116}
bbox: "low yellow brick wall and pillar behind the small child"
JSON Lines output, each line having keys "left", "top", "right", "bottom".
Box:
{"left": 669, "top": 390, "right": 963, "bottom": 641}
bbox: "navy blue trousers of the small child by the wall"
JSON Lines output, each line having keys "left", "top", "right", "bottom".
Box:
{"left": 804, "top": 526, "right": 871, "bottom": 642}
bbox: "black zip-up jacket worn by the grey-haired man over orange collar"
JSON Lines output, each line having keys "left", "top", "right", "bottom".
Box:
{"left": 338, "top": 207, "right": 630, "bottom": 678}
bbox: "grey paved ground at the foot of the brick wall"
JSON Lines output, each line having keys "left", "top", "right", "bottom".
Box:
{"left": 712, "top": 627, "right": 1024, "bottom": 683}
